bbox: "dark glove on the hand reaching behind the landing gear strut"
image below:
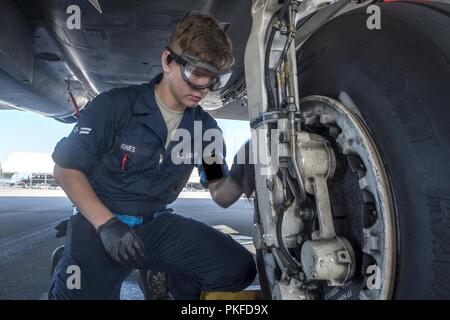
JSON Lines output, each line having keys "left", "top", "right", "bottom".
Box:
{"left": 229, "top": 140, "right": 255, "bottom": 198}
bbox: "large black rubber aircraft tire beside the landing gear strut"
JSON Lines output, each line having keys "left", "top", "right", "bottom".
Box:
{"left": 292, "top": 2, "right": 450, "bottom": 299}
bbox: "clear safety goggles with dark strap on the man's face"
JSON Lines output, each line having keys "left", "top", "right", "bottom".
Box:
{"left": 166, "top": 47, "right": 232, "bottom": 91}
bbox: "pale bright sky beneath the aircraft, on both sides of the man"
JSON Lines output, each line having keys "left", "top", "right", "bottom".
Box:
{"left": 0, "top": 110, "right": 250, "bottom": 163}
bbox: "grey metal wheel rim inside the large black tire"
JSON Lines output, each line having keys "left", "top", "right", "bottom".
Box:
{"left": 256, "top": 96, "right": 397, "bottom": 299}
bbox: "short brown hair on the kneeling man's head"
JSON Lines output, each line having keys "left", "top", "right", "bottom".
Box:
{"left": 169, "top": 13, "right": 234, "bottom": 69}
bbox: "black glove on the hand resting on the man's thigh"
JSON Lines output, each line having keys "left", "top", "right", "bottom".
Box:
{"left": 97, "top": 217, "right": 144, "bottom": 269}
